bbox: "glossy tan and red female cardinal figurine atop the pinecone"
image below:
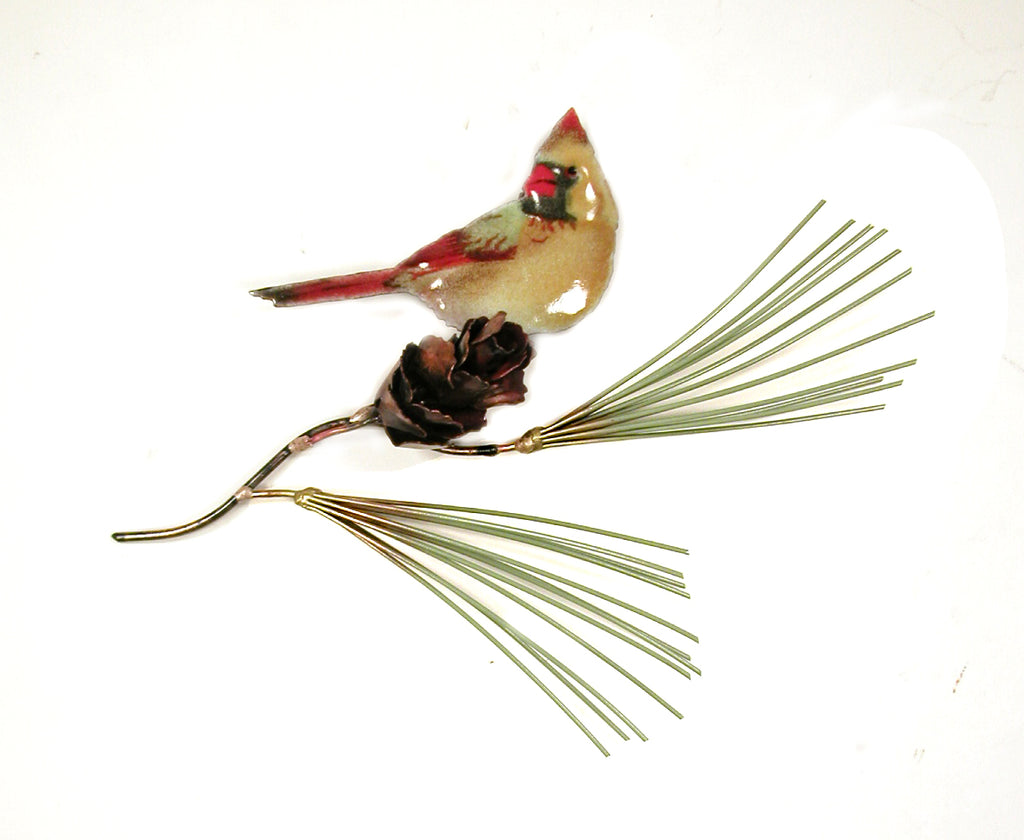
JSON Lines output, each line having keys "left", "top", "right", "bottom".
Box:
{"left": 252, "top": 109, "right": 618, "bottom": 333}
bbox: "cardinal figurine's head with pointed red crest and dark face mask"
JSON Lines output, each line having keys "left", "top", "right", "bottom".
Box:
{"left": 519, "top": 108, "right": 618, "bottom": 227}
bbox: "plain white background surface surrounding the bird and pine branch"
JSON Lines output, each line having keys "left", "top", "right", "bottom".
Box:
{"left": 0, "top": 0, "right": 1024, "bottom": 840}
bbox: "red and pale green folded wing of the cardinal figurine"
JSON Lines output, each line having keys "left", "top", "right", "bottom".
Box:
{"left": 397, "top": 202, "right": 525, "bottom": 276}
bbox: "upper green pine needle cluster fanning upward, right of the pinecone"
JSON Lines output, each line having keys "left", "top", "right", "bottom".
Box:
{"left": 440, "top": 202, "right": 935, "bottom": 455}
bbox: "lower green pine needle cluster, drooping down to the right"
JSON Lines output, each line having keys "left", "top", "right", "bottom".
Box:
{"left": 253, "top": 489, "right": 700, "bottom": 755}
